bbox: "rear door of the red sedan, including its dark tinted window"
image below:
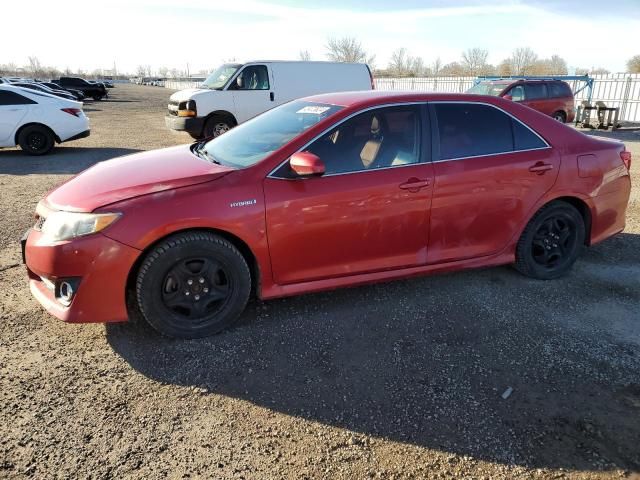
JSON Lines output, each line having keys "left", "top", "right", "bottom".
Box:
{"left": 428, "top": 102, "right": 560, "bottom": 263}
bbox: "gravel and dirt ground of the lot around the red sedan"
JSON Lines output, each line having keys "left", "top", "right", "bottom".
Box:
{"left": 0, "top": 85, "right": 640, "bottom": 479}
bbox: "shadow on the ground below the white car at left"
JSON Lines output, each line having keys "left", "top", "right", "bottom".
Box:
{"left": 0, "top": 146, "right": 140, "bottom": 175}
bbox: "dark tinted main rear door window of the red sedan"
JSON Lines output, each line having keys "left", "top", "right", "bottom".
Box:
{"left": 434, "top": 103, "right": 513, "bottom": 160}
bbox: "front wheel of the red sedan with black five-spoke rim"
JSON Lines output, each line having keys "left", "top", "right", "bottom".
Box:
{"left": 135, "top": 232, "right": 251, "bottom": 338}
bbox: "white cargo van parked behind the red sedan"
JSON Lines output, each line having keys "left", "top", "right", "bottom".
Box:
{"left": 165, "top": 61, "right": 373, "bottom": 138}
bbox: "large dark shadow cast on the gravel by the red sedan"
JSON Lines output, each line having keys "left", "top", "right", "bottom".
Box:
{"left": 106, "top": 234, "right": 640, "bottom": 471}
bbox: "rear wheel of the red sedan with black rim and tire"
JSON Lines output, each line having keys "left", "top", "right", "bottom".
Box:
{"left": 515, "top": 201, "right": 585, "bottom": 280}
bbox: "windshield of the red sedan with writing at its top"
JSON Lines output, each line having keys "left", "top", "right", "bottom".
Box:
{"left": 200, "top": 100, "right": 342, "bottom": 168}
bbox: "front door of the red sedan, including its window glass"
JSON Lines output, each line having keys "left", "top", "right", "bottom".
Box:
{"left": 264, "top": 105, "right": 433, "bottom": 285}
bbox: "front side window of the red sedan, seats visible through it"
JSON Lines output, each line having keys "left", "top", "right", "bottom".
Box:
{"left": 306, "top": 106, "right": 420, "bottom": 175}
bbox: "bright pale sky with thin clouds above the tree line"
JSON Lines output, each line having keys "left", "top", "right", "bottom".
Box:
{"left": 0, "top": 0, "right": 640, "bottom": 73}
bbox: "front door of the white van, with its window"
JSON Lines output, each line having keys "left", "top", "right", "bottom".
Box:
{"left": 229, "top": 65, "right": 276, "bottom": 123}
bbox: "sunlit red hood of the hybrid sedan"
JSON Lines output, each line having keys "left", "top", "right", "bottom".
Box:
{"left": 44, "top": 145, "right": 233, "bottom": 212}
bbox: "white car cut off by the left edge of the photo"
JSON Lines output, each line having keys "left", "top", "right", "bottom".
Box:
{"left": 0, "top": 83, "right": 90, "bottom": 155}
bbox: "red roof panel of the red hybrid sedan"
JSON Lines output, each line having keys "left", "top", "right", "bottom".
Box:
{"left": 304, "top": 90, "right": 508, "bottom": 107}
